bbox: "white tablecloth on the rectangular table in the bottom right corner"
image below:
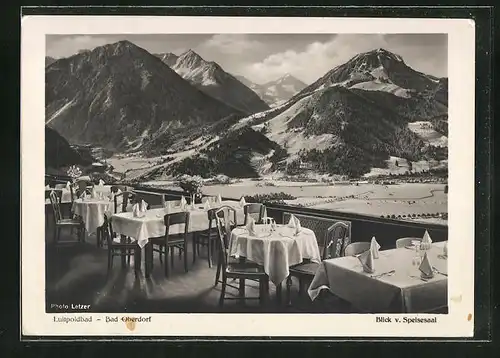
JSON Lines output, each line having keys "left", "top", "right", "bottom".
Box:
{"left": 308, "top": 242, "right": 448, "bottom": 313}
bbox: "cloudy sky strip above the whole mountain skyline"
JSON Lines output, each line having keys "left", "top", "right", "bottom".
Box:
{"left": 46, "top": 34, "right": 448, "bottom": 84}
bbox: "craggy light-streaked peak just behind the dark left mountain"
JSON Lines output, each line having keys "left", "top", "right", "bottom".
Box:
{"left": 171, "top": 50, "right": 269, "bottom": 114}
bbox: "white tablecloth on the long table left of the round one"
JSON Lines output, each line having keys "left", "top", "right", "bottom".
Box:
{"left": 112, "top": 201, "right": 244, "bottom": 247}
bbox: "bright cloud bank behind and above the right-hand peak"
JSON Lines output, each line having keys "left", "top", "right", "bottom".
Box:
{"left": 241, "top": 34, "right": 446, "bottom": 84}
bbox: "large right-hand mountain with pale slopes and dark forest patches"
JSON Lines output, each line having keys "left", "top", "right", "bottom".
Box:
{"left": 141, "top": 49, "right": 448, "bottom": 180}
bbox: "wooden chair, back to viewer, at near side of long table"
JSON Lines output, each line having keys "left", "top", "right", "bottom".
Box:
{"left": 149, "top": 212, "right": 190, "bottom": 277}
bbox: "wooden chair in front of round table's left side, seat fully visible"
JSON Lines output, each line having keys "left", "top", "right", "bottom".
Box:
{"left": 216, "top": 208, "right": 269, "bottom": 307}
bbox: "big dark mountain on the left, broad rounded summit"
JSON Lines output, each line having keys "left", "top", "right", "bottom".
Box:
{"left": 45, "top": 41, "right": 241, "bottom": 150}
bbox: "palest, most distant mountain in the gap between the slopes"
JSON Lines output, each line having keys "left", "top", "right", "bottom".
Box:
{"left": 236, "top": 73, "right": 307, "bottom": 107}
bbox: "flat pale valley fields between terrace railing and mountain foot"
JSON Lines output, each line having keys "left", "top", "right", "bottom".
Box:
{"left": 144, "top": 180, "right": 448, "bottom": 224}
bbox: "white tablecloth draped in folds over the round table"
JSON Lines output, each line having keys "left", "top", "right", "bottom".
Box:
{"left": 229, "top": 225, "right": 321, "bottom": 285}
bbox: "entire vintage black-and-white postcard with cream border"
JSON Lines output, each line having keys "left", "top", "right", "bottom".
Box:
{"left": 21, "top": 16, "right": 475, "bottom": 339}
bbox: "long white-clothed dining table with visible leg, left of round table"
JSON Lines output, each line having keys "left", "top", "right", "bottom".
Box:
{"left": 111, "top": 200, "right": 244, "bottom": 277}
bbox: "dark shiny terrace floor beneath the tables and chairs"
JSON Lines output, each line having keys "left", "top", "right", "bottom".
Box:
{"left": 46, "top": 218, "right": 353, "bottom": 313}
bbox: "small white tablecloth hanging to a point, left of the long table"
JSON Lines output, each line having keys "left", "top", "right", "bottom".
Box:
{"left": 73, "top": 199, "right": 114, "bottom": 234}
